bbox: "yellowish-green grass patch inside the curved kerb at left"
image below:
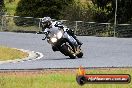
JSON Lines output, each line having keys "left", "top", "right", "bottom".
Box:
{"left": 0, "top": 46, "right": 28, "bottom": 61}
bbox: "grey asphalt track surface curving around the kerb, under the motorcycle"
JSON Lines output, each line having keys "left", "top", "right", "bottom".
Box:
{"left": 0, "top": 32, "right": 132, "bottom": 69}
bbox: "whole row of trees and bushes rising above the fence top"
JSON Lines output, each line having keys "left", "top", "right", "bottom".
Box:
{"left": 0, "top": 0, "right": 132, "bottom": 23}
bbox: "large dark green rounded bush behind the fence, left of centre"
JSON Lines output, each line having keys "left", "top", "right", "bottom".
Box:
{"left": 15, "top": 0, "right": 73, "bottom": 19}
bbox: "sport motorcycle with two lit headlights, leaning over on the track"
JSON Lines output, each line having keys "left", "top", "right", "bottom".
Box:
{"left": 42, "top": 29, "right": 83, "bottom": 59}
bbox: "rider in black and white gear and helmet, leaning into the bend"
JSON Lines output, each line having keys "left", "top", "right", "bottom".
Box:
{"left": 41, "top": 17, "right": 82, "bottom": 45}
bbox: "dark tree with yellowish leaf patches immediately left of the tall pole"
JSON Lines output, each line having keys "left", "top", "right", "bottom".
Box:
{"left": 92, "top": 0, "right": 113, "bottom": 22}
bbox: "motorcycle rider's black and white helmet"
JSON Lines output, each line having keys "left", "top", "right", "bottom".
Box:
{"left": 41, "top": 17, "right": 51, "bottom": 29}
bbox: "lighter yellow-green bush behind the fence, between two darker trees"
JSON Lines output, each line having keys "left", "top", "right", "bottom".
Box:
{"left": 63, "top": 0, "right": 94, "bottom": 21}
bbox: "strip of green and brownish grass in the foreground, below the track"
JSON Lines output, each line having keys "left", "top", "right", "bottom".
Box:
{"left": 0, "top": 68, "right": 132, "bottom": 88}
